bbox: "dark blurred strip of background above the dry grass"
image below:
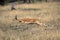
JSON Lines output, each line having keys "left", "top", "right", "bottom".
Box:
{"left": 0, "top": 0, "right": 60, "bottom": 5}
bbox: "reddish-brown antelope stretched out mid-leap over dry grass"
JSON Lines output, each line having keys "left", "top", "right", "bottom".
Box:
{"left": 15, "top": 15, "right": 45, "bottom": 25}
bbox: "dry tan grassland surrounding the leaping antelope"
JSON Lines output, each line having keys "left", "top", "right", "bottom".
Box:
{"left": 0, "top": 2, "right": 60, "bottom": 40}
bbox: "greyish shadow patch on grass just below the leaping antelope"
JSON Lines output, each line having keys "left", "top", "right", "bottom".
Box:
{"left": 10, "top": 23, "right": 38, "bottom": 31}
